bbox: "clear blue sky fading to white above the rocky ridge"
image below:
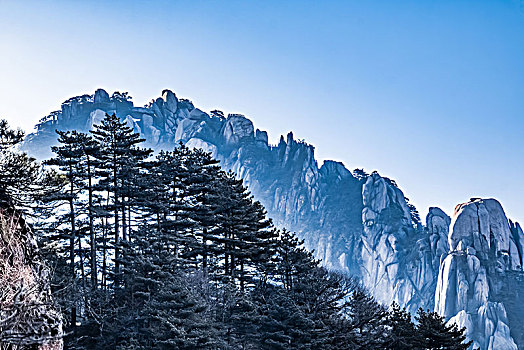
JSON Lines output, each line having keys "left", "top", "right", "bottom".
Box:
{"left": 0, "top": 0, "right": 524, "bottom": 222}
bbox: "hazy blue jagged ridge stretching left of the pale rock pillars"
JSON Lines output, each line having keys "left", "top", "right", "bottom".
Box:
{"left": 23, "top": 89, "right": 363, "bottom": 273}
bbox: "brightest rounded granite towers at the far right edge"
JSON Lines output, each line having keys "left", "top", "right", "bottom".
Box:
{"left": 435, "top": 199, "right": 524, "bottom": 350}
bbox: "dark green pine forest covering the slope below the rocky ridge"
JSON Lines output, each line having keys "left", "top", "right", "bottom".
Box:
{"left": 0, "top": 114, "right": 468, "bottom": 349}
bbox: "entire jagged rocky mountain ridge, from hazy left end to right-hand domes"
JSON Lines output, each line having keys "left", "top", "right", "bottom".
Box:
{"left": 23, "top": 89, "right": 524, "bottom": 349}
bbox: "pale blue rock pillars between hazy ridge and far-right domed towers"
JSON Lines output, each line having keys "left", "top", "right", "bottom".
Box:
{"left": 360, "top": 173, "right": 449, "bottom": 312}
